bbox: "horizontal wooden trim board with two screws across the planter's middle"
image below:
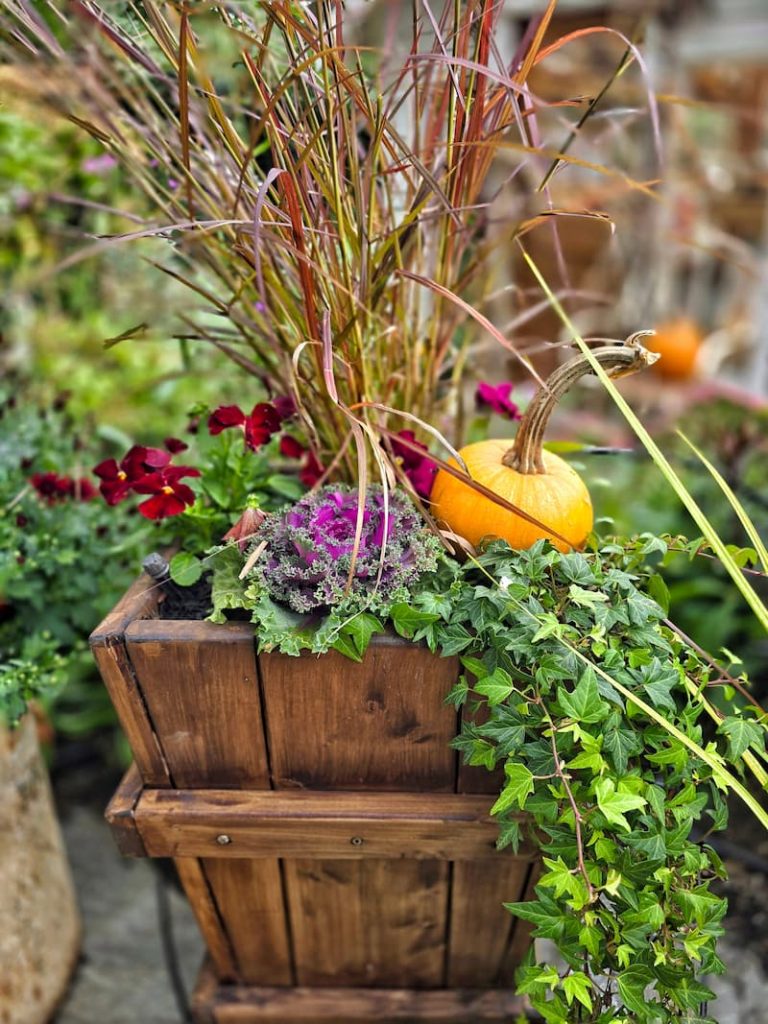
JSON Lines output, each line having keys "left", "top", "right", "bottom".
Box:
{"left": 136, "top": 790, "right": 531, "bottom": 860}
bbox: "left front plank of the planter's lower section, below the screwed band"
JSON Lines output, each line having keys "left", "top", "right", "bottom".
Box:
{"left": 204, "top": 859, "right": 293, "bottom": 985}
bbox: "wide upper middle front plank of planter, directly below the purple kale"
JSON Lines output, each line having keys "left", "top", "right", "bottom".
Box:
{"left": 259, "top": 637, "right": 459, "bottom": 792}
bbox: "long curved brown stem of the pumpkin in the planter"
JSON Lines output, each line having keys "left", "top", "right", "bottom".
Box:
{"left": 502, "top": 339, "right": 658, "bottom": 473}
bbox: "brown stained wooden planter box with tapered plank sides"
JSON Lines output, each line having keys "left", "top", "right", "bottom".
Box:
{"left": 91, "top": 580, "right": 538, "bottom": 1024}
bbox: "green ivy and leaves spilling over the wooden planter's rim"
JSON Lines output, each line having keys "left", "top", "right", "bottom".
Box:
{"left": 214, "top": 537, "right": 766, "bottom": 1024}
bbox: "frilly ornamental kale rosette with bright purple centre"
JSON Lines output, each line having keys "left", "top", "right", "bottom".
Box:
{"left": 243, "top": 485, "right": 440, "bottom": 612}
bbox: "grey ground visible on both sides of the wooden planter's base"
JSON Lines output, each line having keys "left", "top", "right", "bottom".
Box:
{"left": 49, "top": 779, "right": 768, "bottom": 1024}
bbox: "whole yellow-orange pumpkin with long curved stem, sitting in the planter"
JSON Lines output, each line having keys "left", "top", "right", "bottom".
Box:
{"left": 430, "top": 332, "right": 658, "bottom": 551}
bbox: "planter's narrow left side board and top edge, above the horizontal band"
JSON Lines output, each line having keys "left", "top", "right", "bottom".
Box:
{"left": 90, "top": 575, "right": 171, "bottom": 786}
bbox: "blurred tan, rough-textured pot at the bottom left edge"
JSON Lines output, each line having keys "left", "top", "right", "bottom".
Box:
{"left": 0, "top": 715, "right": 80, "bottom": 1024}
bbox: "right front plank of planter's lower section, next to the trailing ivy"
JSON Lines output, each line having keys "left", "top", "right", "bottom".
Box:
{"left": 445, "top": 853, "right": 529, "bottom": 988}
